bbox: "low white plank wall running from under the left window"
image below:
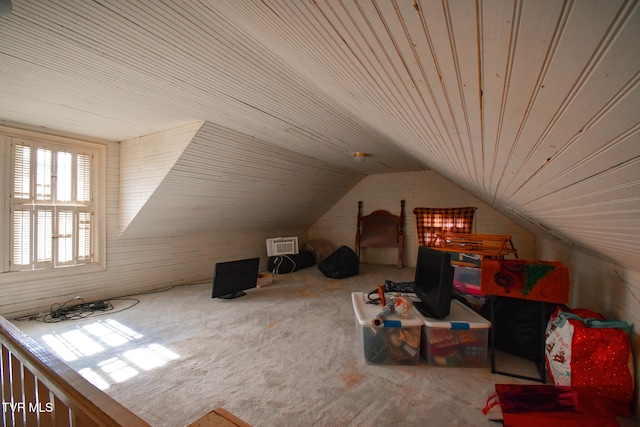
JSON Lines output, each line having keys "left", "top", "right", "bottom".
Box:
{"left": 0, "top": 142, "right": 307, "bottom": 319}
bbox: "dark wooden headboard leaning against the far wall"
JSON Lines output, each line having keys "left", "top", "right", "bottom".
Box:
{"left": 356, "top": 200, "right": 404, "bottom": 268}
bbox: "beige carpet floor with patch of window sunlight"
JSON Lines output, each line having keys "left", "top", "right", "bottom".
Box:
{"left": 14, "top": 264, "right": 548, "bottom": 427}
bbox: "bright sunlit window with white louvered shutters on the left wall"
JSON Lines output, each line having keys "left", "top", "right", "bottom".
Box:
{"left": 2, "top": 129, "right": 104, "bottom": 271}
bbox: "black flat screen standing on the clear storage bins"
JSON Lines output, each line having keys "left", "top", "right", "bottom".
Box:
{"left": 414, "top": 246, "right": 453, "bottom": 319}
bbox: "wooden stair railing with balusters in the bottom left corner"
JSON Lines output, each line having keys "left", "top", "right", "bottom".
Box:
{"left": 0, "top": 316, "right": 149, "bottom": 427}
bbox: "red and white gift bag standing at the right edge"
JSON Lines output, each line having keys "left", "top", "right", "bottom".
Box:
{"left": 545, "top": 308, "right": 634, "bottom": 417}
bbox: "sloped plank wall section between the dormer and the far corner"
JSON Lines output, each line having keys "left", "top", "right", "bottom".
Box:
{"left": 121, "top": 122, "right": 364, "bottom": 238}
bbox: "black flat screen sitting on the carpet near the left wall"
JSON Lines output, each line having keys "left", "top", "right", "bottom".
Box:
{"left": 211, "top": 258, "right": 260, "bottom": 299}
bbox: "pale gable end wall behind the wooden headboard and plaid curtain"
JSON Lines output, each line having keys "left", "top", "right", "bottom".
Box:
{"left": 309, "top": 171, "right": 536, "bottom": 266}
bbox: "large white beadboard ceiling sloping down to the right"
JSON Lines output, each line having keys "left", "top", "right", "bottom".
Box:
{"left": 0, "top": 0, "right": 640, "bottom": 270}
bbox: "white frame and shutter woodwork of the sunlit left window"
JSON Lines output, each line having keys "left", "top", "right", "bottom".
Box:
{"left": 0, "top": 126, "right": 107, "bottom": 284}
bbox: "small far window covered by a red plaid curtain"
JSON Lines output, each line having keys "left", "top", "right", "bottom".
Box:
{"left": 413, "top": 207, "right": 476, "bottom": 246}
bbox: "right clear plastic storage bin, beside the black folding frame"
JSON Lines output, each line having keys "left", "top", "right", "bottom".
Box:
{"left": 415, "top": 300, "right": 491, "bottom": 367}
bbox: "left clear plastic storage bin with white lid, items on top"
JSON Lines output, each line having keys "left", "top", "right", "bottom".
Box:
{"left": 351, "top": 292, "right": 424, "bottom": 365}
